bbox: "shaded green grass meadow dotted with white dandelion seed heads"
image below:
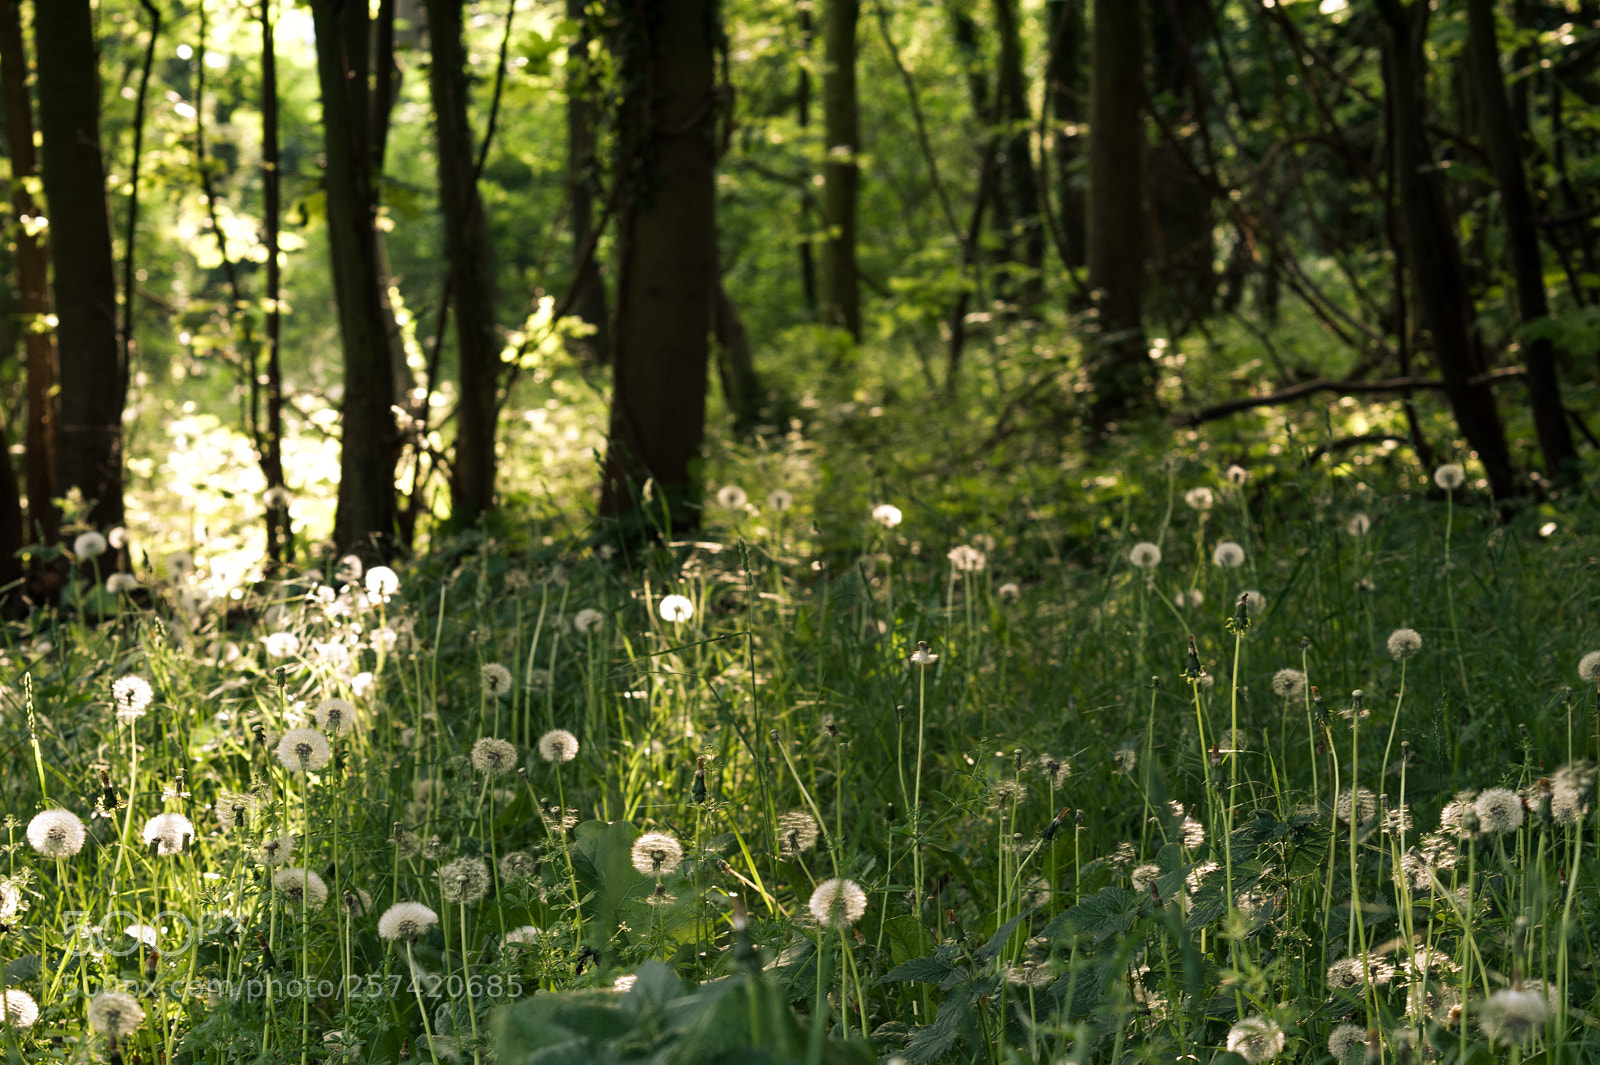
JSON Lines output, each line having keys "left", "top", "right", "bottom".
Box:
{"left": 0, "top": 441, "right": 1600, "bottom": 1065}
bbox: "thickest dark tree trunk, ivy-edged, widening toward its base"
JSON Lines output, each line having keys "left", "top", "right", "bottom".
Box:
{"left": 600, "top": 0, "right": 718, "bottom": 539}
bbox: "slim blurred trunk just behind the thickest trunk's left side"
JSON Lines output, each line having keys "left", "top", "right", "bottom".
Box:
{"left": 566, "top": 0, "right": 611, "bottom": 363}
